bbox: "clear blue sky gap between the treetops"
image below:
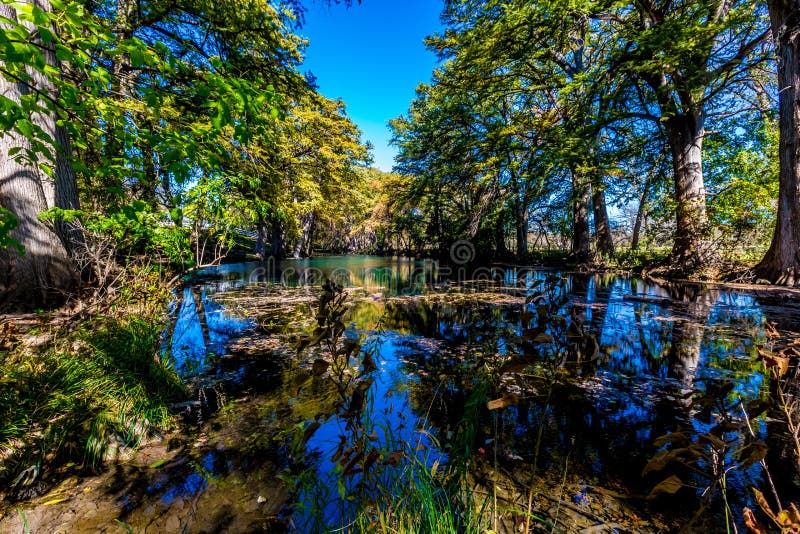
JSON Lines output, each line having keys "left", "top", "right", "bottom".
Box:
{"left": 300, "top": 0, "right": 442, "bottom": 171}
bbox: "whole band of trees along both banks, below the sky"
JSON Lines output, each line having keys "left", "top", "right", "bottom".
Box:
{"left": 0, "top": 2, "right": 800, "bottom": 309}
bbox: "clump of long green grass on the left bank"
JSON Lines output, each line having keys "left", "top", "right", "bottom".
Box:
{"left": 0, "top": 316, "right": 187, "bottom": 485}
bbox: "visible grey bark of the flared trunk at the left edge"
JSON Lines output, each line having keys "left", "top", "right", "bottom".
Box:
{"left": 0, "top": 4, "right": 78, "bottom": 309}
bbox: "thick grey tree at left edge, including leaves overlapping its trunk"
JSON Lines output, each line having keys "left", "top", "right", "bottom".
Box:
{"left": 0, "top": 1, "right": 78, "bottom": 308}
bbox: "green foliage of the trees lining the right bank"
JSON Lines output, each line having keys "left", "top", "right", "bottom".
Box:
{"left": 392, "top": 0, "right": 776, "bottom": 268}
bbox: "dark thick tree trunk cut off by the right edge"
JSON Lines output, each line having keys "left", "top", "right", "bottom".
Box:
{"left": 755, "top": 0, "right": 800, "bottom": 286}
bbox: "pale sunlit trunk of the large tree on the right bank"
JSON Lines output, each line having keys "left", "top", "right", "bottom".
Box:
{"left": 664, "top": 113, "right": 716, "bottom": 274}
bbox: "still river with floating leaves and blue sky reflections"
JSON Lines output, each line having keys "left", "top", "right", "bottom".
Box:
{"left": 1, "top": 256, "right": 800, "bottom": 532}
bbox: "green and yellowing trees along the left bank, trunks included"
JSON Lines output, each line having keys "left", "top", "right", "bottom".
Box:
{"left": 0, "top": 0, "right": 370, "bottom": 308}
